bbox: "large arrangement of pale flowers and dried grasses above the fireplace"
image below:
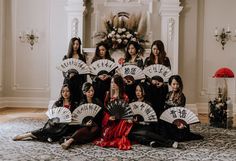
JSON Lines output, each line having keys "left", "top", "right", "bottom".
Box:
{"left": 94, "top": 12, "right": 148, "bottom": 50}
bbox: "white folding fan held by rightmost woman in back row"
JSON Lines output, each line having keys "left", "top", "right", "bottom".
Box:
{"left": 143, "top": 64, "right": 172, "bottom": 82}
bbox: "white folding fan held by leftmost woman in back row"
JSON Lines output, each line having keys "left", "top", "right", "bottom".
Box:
{"left": 56, "top": 58, "right": 90, "bottom": 74}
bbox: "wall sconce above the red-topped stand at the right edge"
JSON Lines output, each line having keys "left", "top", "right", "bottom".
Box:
{"left": 214, "top": 26, "right": 236, "bottom": 50}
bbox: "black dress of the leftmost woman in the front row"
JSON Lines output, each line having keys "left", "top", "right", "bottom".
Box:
{"left": 31, "top": 100, "right": 77, "bottom": 142}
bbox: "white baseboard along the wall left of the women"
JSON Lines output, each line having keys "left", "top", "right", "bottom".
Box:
{"left": 0, "top": 97, "right": 49, "bottom": 108}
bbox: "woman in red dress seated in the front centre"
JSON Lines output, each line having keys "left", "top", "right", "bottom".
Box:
{"left": 95, "top": 75, "right": 133, "bottom": 150}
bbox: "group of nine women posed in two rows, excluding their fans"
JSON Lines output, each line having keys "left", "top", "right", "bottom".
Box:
{"left": 13, "top": 38, "right": 203, "bottom": 150}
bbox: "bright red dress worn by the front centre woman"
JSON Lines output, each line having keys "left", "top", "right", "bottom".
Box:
{"left": 94, "top": 94, "right": 133, "bottom": 150}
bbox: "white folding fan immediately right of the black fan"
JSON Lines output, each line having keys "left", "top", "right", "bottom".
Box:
{"left": 129, "top": 101, "right": 157, "bottom": 122}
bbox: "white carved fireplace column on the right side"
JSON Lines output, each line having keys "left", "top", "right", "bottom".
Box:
{"left": 159, "top": 0, "right": 183, "bottom": 74}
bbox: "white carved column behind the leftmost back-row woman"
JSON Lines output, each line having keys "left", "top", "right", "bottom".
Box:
{"left": 65, "top": 0, "right": 86, "bottom": 42}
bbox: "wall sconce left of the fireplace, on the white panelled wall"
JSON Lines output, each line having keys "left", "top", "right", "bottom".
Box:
{"left": 19, "top": 30, "right": 39, "bottom": 50}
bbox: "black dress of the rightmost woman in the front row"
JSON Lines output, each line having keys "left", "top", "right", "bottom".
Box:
{"left": 158, "top": 91, "right": 203, "bottom": 142}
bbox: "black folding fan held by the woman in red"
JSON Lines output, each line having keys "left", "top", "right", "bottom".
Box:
{"left": 107, "top": 99, "right": 133, "bottom": 119}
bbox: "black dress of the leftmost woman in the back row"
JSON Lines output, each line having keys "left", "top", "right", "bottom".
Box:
{"left": 63, "top": 55, "right": 87, "bottom": 102}
